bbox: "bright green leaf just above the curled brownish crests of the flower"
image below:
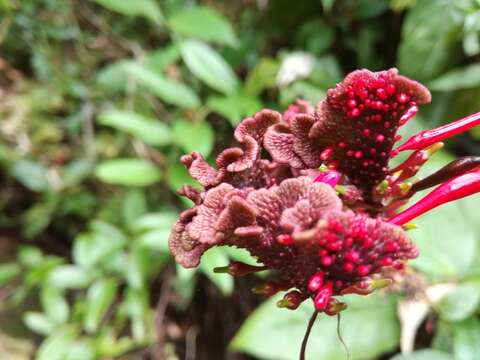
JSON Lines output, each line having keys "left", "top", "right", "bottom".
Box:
{"left": 207, "top": 94, "right": 262, "bottom": 126}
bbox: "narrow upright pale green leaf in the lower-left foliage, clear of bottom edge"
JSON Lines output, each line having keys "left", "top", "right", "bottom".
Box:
{"left": 83, "top": 279, "right": 117, "bottom": 333}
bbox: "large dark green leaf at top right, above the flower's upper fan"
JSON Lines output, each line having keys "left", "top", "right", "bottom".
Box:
{"left": 398, "top": 0, "right": 464, "bottom": 81}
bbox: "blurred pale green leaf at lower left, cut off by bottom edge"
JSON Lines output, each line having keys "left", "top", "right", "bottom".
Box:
{"left": 35, "top": 326, "right": 79, "bottom": 360}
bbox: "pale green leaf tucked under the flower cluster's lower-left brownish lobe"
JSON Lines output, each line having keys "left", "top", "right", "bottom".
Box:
{"left": 199, "top": 247, "right": 233, "bottom": 295}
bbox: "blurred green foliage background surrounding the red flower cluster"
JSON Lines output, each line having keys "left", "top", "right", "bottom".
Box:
{"left": 0, "top": 0, "right": 480, "bottom": 360}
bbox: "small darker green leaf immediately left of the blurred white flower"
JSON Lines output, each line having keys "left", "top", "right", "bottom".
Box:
{"left": 245, "top": 57, "right": 280, "bottom": 96}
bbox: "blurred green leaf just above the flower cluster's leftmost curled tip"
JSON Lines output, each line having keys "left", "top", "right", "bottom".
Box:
{"left": 172, "top": 119, "right": 215, "bottom": 157}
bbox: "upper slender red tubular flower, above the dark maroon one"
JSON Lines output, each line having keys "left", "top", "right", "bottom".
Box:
{"left": 395, "top": 112, "right": 480, "bottom": 151}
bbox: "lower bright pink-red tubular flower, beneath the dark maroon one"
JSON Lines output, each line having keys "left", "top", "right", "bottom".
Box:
{"left": 388, "top": 169, "right": 480, "bottom": 225}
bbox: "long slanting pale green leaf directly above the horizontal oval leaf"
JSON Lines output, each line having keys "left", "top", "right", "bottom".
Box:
{"left": 98, "top": 110, "right": 170, "bottom": 146}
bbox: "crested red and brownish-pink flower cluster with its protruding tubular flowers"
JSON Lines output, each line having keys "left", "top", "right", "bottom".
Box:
{"left": 169, "top": 69, "right": 480, "bottom": 315}
